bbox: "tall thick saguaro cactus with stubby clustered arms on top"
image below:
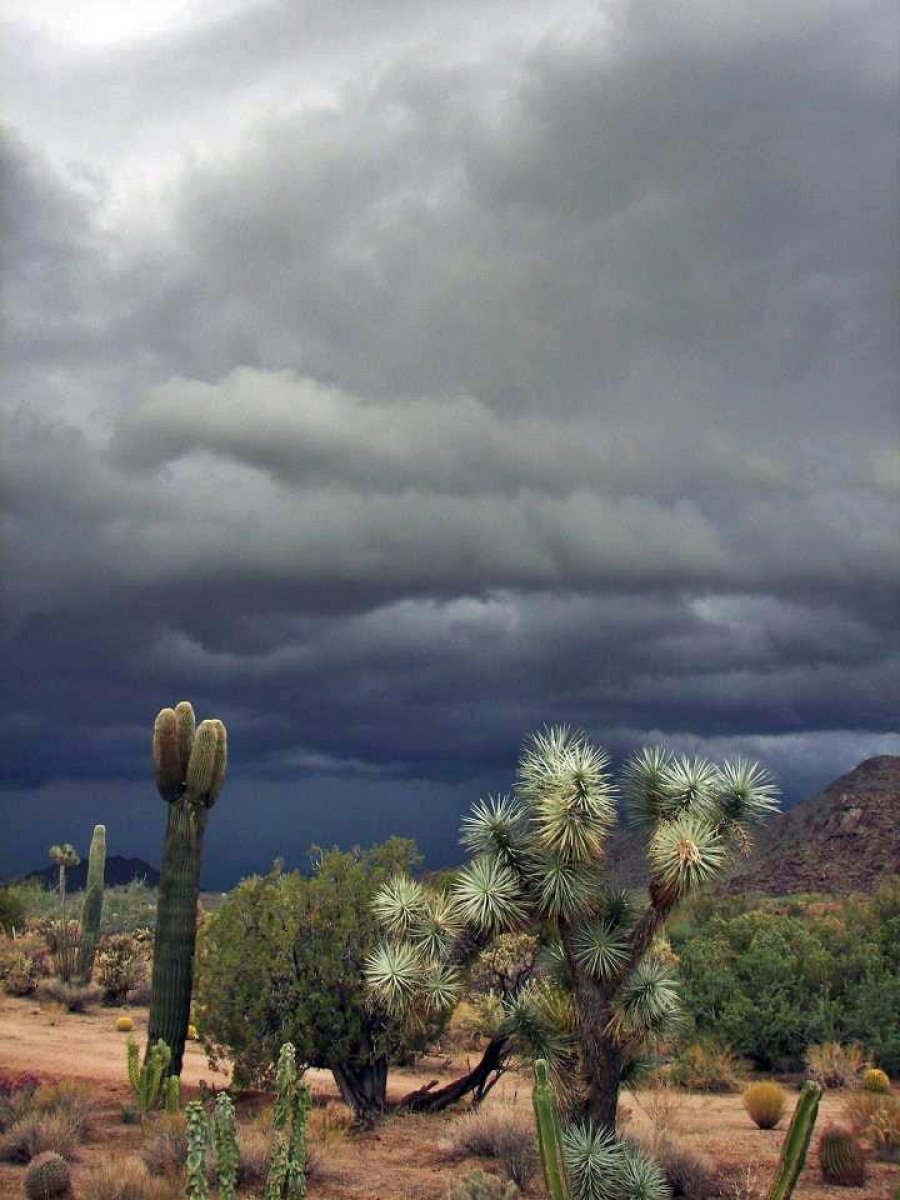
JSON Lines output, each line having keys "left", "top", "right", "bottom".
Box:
{"left": 148, "top": 700, "right": 228, "bottom": 1075}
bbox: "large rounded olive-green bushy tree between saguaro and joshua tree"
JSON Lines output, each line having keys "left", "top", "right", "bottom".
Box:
{"left": 194, "top": 839, "right": 431, "bottom": 1111}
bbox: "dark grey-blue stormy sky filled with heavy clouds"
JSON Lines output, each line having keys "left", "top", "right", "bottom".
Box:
{"left": 0, "top": 0, "right": 900, "bottom": 887}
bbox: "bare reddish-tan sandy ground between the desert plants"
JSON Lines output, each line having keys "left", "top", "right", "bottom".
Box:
{"left": 0, "top": 996, "right": 900, "bottom": 1200}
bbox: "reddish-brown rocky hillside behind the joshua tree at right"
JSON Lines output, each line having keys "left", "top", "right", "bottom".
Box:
{"left": 608, "top": 755, "right": 900, "bottom": 895}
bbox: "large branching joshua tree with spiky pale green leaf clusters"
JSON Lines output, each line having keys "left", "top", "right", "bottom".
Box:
{"left": 367, "top": 727, "right": 778, "bottom": 1128}
